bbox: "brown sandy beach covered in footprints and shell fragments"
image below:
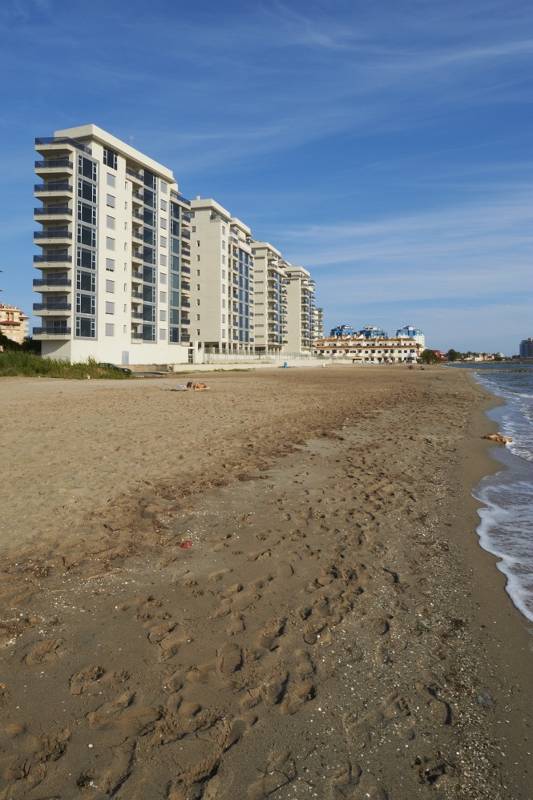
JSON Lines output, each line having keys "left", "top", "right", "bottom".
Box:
{"left": 0, "top": 367, "right": 533, "bottom": 800}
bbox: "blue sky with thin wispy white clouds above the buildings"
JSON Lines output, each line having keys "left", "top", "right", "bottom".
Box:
{"left": 0, "top": 0, "right": 533, "bottom": 353}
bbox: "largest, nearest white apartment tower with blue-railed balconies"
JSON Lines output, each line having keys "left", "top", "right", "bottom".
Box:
{"left": 33, "top": 125, "right": 191, "bottom": 364}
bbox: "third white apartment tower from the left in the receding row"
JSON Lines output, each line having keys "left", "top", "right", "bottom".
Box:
{"left": 252, "top": 241, "right": 288, "bottom": 355}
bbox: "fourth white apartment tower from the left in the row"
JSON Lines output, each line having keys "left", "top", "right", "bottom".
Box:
{"left": 283, "top": 264, "right": 315, "bottom": 353}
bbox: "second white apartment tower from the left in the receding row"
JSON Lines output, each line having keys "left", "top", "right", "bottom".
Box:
{"left": 191, "top": 197, "right": 255, "bottom": 357}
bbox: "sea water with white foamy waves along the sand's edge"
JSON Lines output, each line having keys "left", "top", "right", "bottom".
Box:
{"left": 458, "top": 362, "right": 533, "bottom": 621}
